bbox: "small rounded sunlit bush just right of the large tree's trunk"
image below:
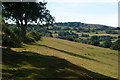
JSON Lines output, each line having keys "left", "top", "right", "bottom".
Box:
{"left": 26, "top": 31, "right": 42, "bottom": 42}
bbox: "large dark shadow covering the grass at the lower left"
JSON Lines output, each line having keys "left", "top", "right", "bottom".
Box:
{"left": 3, "top": 48, "right": 115, "bottom": 80}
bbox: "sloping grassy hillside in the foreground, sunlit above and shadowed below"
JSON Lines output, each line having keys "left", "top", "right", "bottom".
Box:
{"left": 3, "top": 37, "right": 118, "bottom": 80}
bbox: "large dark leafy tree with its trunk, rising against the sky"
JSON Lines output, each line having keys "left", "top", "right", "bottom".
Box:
{"left": 2, "top": 2, "right": 54, "bottom": 41}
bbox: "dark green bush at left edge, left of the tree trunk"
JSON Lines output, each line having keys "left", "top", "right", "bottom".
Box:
{"left": 2, "top": 23, "right": 21, "bottom": 47}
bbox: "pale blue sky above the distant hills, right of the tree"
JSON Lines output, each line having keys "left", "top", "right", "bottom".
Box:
{"left": 39, "top": 0, "right": 119, "bottom": 27}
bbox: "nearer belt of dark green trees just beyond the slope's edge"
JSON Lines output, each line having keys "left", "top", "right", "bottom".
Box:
{"left": 54, "top": 31, "right": 120, "bottom": 50}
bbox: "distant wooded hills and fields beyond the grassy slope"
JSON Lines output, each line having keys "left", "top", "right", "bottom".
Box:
{"left": 36, "top": 22, "right": 119, "bottom": 50}
